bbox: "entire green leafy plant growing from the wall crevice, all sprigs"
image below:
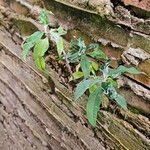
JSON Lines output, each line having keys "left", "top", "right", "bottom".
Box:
{"left": 22, "top": 10, "right": 140, "bottom": 127}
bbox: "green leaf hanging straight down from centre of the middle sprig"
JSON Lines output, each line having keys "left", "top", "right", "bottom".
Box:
{"left": 80, "top": 56, "right": 91, "bottom": 78}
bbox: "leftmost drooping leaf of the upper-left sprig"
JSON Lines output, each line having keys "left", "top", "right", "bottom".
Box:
{"left": 21, "top": 42, "right": 34, "bottom": 60}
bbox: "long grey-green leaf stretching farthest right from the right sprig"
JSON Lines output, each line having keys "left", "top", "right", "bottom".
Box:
{"left": 108, "top": 66, "right": 141, "bottom": 78}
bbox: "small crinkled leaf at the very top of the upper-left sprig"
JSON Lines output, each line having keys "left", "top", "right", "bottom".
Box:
{"left": 38, "top": 9, "right": 48, "bottom": 25}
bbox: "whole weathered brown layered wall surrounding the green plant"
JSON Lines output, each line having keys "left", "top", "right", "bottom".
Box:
{"left": 0, "top": 0, "right": 150, "bottom": 150}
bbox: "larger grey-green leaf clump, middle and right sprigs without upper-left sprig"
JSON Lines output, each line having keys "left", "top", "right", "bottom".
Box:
{"left": 68, "top": 38, "right": 140, "bottom": 127}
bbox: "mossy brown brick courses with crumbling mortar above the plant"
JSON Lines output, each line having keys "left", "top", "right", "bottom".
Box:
{"left": 11, "top": 0, "right": 150, "bottom": 115}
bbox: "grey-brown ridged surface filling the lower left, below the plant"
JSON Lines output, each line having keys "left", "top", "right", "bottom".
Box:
{"left": 0, "top": 27, "right": 104, "bottom": 150}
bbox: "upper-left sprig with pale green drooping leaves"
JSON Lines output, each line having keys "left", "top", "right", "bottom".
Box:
{"left": 22, "top": 10, "right": 66, "bottom": 71}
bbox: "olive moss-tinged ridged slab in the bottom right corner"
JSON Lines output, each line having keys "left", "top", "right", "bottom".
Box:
{"left": 101, "top": 112, "right": 149, "bottom": 150}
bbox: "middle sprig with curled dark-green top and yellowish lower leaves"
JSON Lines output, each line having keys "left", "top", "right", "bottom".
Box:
{"left": 67, "top": 38, "right": 108, "bottom": 80}
